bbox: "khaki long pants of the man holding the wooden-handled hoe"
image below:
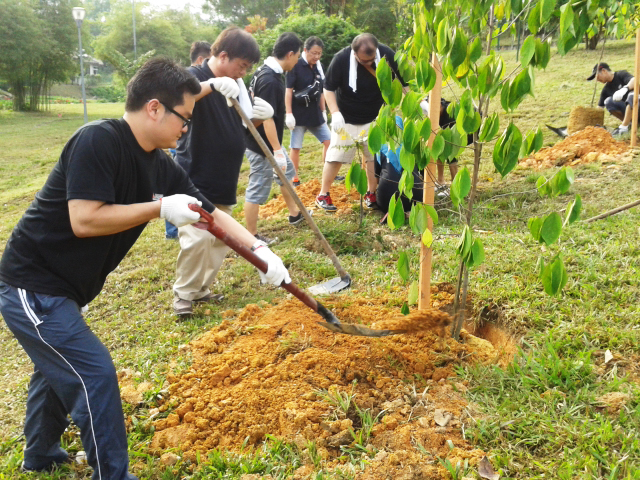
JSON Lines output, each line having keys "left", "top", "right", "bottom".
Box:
{"left": 173, "top": 205, "right": 234, "bottom": 300}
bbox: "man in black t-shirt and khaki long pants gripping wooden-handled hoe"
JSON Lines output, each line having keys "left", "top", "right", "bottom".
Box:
{"left": 173, "top": 27, "right": 273, "bottom": 316}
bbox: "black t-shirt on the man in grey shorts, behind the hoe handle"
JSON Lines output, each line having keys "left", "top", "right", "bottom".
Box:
{"left": 247, "top": 65, "right": 286, "bottom": 155}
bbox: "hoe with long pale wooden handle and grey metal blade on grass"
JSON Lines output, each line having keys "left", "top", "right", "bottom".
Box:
{"left": 229, "top": 98, "right": 351, "bottom": 295}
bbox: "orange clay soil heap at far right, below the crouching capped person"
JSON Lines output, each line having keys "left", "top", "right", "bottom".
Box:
{"left": 520, "top": 127, "right": 629, "bottom": 168}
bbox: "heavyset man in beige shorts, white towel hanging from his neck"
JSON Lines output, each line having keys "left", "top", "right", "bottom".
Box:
{"left": 316, "top": 33, "right": 398, "bottom": 212}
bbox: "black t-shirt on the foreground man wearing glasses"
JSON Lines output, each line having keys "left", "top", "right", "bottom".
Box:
{"left": 0, "top": 118, "right": 214, "bottom": 306}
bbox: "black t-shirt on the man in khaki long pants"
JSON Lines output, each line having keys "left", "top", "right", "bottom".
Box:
{"left": 175, "top": 63, "right": 246, "bottom": 205}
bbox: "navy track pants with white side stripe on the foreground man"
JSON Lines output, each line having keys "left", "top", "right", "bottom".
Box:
{"left": 0, "top": 282, "right": 136, "bottom": 480}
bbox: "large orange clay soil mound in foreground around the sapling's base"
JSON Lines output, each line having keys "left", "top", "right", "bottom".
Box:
{"left": 151, "top": 284, "right": 510, "bottom": 479}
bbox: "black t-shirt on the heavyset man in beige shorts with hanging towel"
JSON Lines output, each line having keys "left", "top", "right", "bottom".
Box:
{"left": 324, "top": 44, "right": 405, "bottom": 125}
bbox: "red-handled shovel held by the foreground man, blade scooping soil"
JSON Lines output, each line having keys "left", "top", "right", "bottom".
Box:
{"left": 189, "top": 205, "right": 404, "bottom": 337}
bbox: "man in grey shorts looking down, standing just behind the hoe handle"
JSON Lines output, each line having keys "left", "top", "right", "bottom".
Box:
{"left": 244, "top": 32, "right": 304, "bottom": 241}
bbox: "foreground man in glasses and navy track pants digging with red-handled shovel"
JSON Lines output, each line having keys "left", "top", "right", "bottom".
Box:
{"left": 0, "top": 59, "right": 290, "bottom": 480}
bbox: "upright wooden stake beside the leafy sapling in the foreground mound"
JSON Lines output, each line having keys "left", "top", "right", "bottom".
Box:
{"left": 418, "top": 53, "right": 442, "bottom": 309}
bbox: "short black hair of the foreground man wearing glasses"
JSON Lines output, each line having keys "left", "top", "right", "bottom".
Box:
{"left": 124, "top": 57, "right": 201, "bottom": 112}
